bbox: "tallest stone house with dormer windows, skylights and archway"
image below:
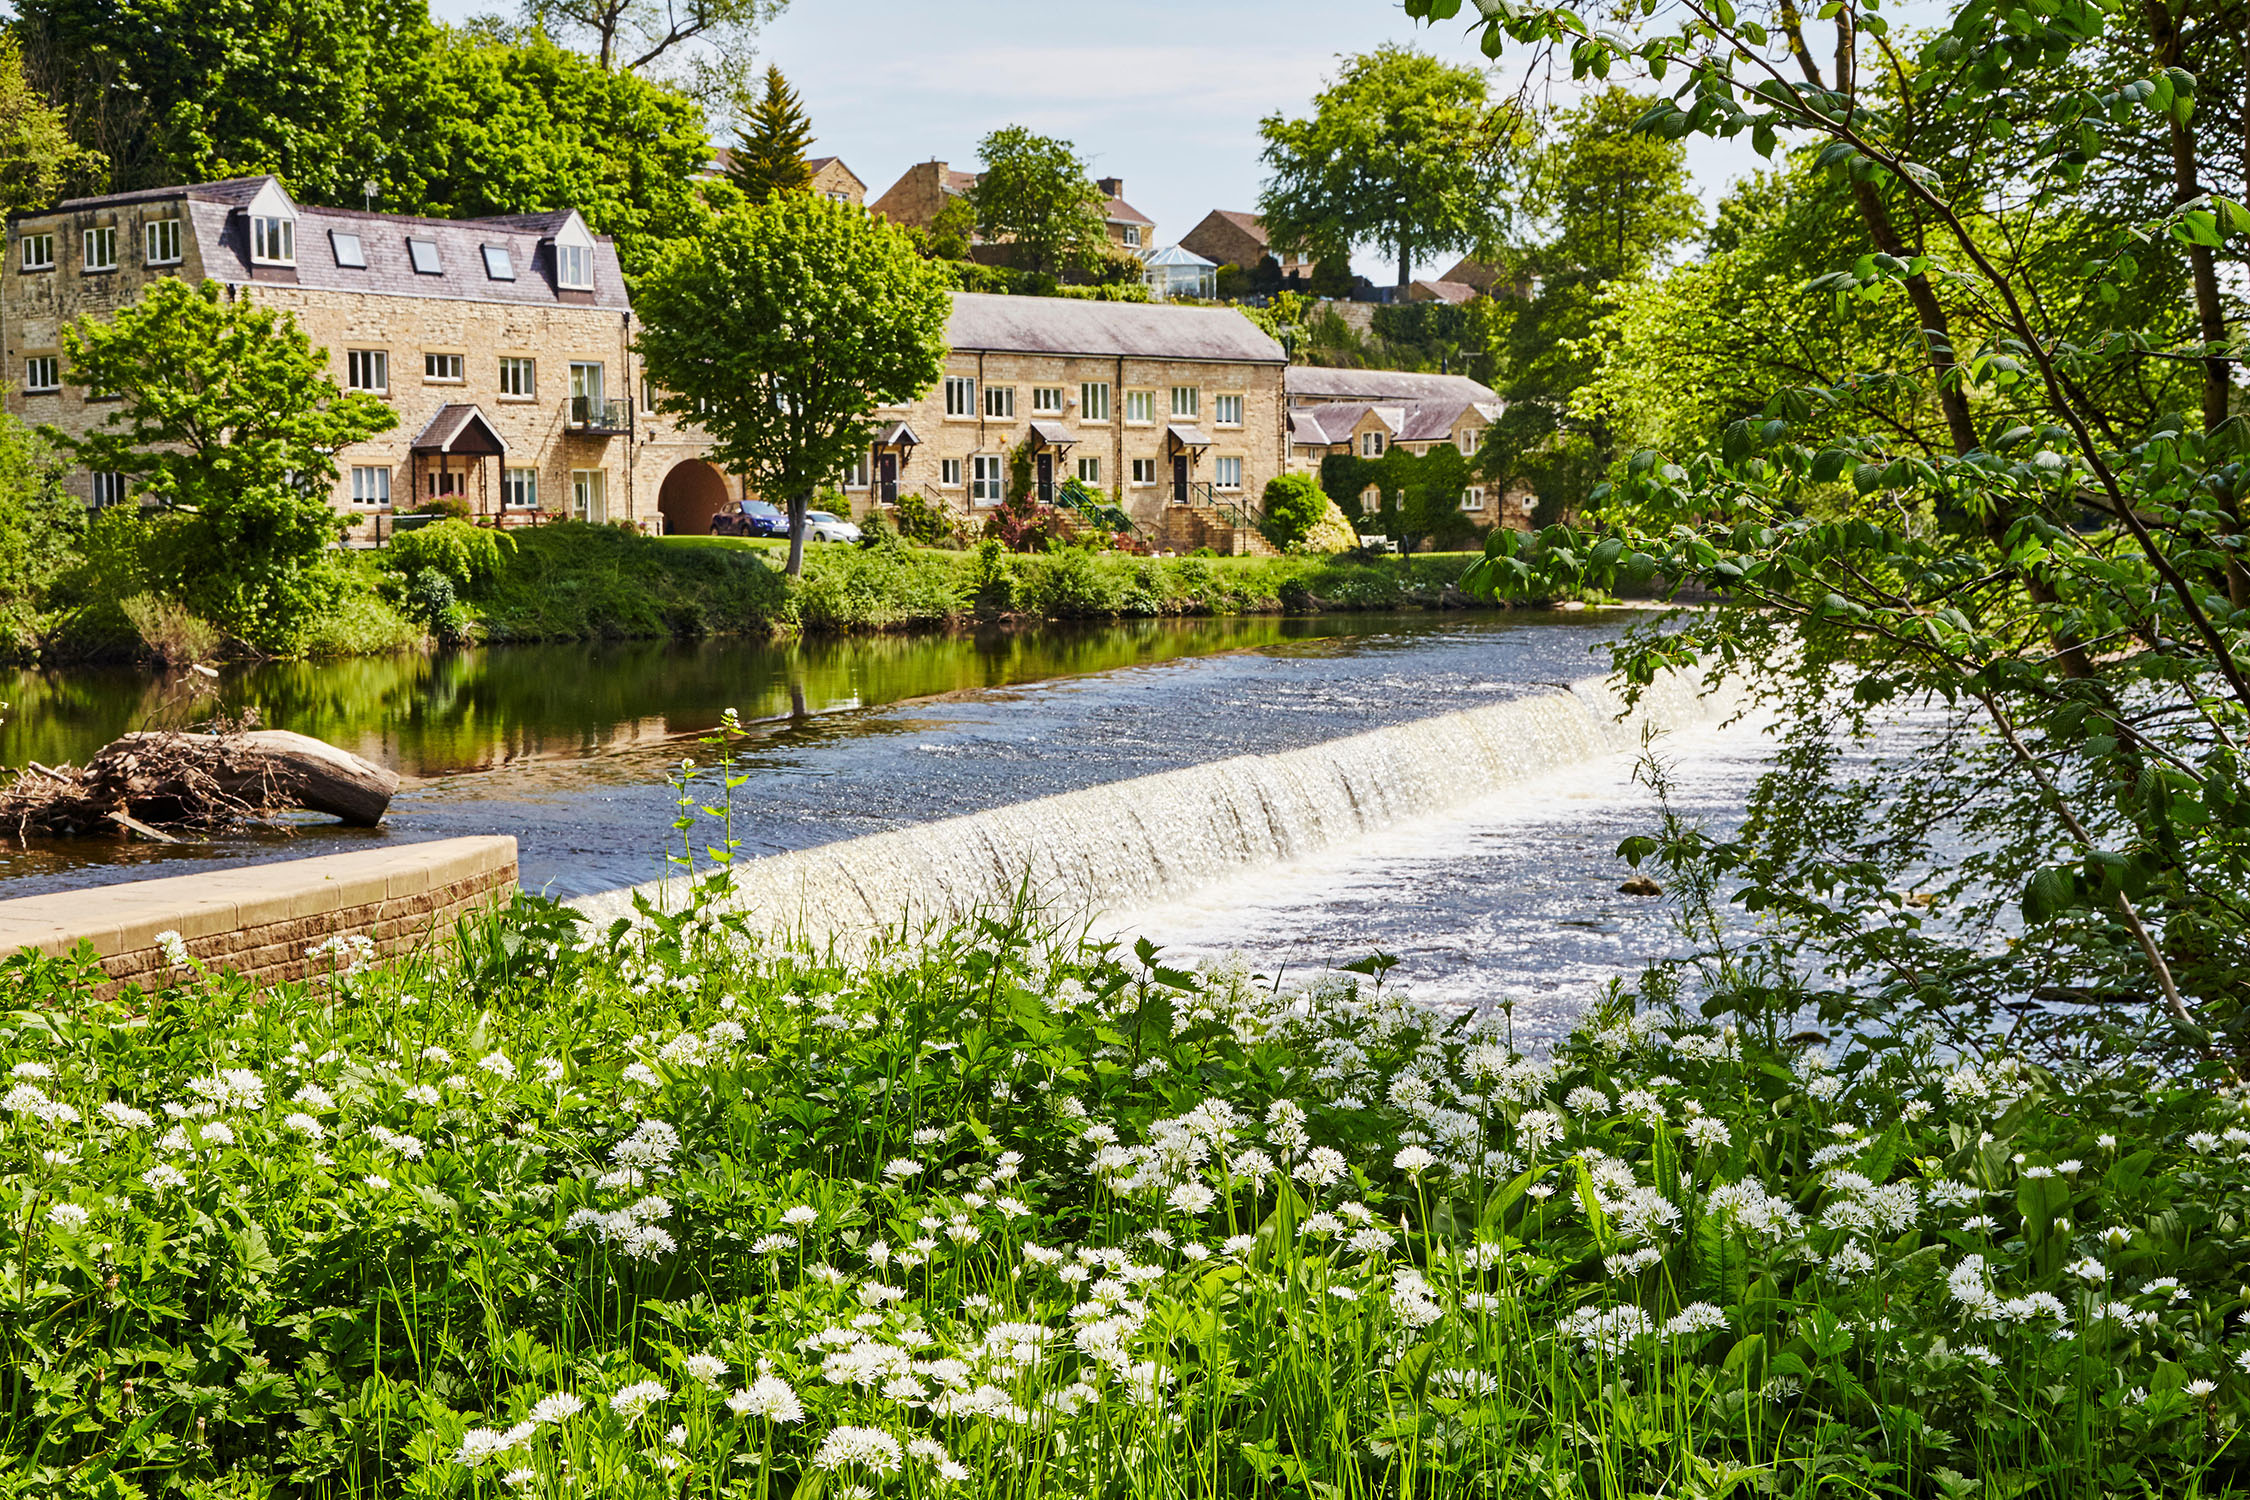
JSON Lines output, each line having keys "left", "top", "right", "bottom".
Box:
{"left": 0, "top": 178, "right": 740, "bottom": 540}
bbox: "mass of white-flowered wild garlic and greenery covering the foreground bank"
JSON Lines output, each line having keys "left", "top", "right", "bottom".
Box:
{"left": 0, "top": 900, "right": 2250, "bottom": 1500}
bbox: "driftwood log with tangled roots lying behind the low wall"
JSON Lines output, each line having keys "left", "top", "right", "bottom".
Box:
{"left": 0, "top": 724, "right": 398, "bottom": 841}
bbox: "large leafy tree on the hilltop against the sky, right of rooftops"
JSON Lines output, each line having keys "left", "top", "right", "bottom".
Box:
{"left": 1258, "top": 45, "right": 1517, "bottom": 286}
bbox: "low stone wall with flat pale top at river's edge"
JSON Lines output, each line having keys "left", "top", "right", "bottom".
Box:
{"left": 0, "top": 837, "right": 515, "bottom": 992}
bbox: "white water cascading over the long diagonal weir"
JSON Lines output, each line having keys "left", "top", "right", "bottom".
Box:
{"left": 572, "top": 675, "right": 1737, "bottom": 940}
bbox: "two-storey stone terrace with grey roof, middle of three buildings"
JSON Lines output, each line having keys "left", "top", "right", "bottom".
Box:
{"left": 844, "top": 292, "right": 1289, "bottom": 546}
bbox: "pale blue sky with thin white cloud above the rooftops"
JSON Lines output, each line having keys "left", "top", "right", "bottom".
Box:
{"left": 432, "top": 0, "right": 1755, "bottom": 283}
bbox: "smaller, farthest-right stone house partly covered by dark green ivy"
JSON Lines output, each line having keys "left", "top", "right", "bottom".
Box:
{"left": 1285, "top": 364, "right": 1532, "bottom": 528}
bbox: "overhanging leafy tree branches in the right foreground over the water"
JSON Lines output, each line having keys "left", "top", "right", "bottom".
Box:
{"left": 1406, "top": 0, "right": 2250, "bottom": 1075}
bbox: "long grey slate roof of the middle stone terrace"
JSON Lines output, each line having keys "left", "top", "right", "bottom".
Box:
{"left": 945, "top": 292, "right": 1289, "bottom": 364}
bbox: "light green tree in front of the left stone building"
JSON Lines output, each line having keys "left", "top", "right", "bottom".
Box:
{"left": 45, "top": 277, "right": 398, "bottom": 650}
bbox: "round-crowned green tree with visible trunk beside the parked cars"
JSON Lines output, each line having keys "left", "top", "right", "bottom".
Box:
{"left": 635, "top": 193, "right": 950, "bottom": 573}
